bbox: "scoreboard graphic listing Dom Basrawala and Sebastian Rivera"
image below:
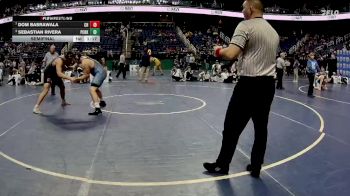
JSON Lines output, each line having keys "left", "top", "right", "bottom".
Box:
{"left": 12, "top": 16, "right": 101, "bottom": 42}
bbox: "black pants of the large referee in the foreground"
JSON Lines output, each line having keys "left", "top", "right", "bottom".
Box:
{"left": 216, "top": 76, "right": 275, "bottom": 168}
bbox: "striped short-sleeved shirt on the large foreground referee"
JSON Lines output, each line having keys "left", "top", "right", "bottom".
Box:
{"left": 231, "top": 18, "right": 279, "bottom": 77}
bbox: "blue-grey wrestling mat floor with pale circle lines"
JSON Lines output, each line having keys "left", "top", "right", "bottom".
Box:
{"left": 0, "top": 74, "right": 350, "bottom": 196}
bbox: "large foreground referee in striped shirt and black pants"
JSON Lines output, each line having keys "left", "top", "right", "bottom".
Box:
{"left": 203, "top": 0, "right": 279, "bottom": 178}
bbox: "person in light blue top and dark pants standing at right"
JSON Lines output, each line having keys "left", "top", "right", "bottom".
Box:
{"left": 306, "top": 52, "right": 320, "bottom": 98}
